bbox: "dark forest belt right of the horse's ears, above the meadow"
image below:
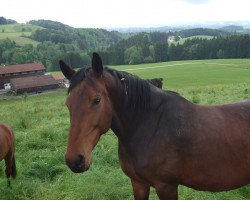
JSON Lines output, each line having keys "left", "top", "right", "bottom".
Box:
{"left": 98, "top": 33, "right": 250, "bottom": 65}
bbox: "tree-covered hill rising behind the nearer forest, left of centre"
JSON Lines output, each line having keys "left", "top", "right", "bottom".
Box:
{"left": 29, "top": 20, "right": 122, "bottom": 51}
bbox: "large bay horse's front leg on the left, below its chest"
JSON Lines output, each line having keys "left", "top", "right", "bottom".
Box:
{"left": 131, "top": 179, "right": 150, "bottom": 200}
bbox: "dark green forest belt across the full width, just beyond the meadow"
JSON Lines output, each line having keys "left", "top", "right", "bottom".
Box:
{"left": 0, "top": 33, "right": 250, "bottom": 71}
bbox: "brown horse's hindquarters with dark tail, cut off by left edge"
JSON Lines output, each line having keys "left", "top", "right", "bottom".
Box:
{"left": 0, "top": 123, "right": 16, "bottom": 186}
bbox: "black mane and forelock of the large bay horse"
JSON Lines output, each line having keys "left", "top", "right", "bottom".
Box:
{"left": 68, "top": 67, "right": 151, "bottom": 108}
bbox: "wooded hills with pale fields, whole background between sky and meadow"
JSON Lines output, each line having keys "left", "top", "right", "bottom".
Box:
{"left": 0, "top": 20, "right": 250, "bottom": 71}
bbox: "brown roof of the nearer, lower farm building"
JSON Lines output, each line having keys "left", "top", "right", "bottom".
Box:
{"left": 10, "top": 75, "right": 58, "bottom": 90}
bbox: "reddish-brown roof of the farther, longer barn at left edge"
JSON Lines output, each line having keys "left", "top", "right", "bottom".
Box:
{"left": 0, "top": 63, "right": 45, "bottom": 74}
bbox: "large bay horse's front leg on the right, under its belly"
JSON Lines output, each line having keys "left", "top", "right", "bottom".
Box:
{"left": 155, "top": 185, "right": 178, "bottom": 200}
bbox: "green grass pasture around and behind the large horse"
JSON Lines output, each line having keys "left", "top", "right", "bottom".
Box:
{"left": 0, "top": 59, "right": 250, "bottom": 200}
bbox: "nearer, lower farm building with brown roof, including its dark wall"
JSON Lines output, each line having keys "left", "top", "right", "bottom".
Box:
{"left": 10, "top": 75, "right": 59, "bottom": 94}
